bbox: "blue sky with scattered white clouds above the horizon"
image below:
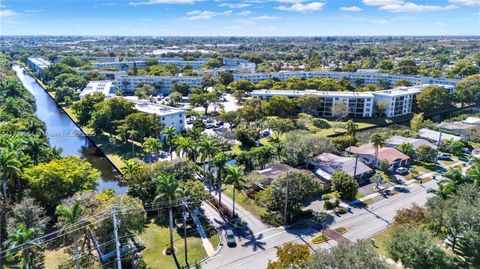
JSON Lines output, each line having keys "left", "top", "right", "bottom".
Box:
{"left": 0, "top": 0, "right": 480, "bottom": 36}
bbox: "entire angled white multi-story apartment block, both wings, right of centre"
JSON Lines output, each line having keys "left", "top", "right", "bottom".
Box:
{"left": 252, "top": 84, "right": 442, "bottom": 117}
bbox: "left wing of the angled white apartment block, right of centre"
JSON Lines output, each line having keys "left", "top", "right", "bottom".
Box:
{"left": 252, "top": 90, "right": 375, "bottom": 118}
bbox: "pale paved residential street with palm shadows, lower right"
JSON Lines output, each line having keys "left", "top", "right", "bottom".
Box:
{"left": 202, "top": 180, "right": 437, "bottom": 269}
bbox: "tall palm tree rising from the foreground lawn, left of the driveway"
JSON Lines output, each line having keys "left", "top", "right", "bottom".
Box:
{"left": 153, "top": 174, "right": 179, "bottom": 253}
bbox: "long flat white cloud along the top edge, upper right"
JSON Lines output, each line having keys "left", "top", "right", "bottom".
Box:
{"left": 362, "top": 0, "right": 460, "bottom": 12}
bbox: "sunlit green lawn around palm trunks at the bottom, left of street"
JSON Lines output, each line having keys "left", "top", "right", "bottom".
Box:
{"left": 140, "top": 218, "right": 218, "bottom": 269}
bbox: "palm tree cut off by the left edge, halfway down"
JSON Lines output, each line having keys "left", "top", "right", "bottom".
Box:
{"left": 0, "top": 148, "right": 22, "bottom": 202}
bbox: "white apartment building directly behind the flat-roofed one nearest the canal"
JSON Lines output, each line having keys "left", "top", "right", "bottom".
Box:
{"left": 114, "top": 76, "right": 202, "bottom": 96}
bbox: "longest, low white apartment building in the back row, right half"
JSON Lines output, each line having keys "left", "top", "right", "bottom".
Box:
{"left": 233, "top": 71, "right": 458, "bottom": 86}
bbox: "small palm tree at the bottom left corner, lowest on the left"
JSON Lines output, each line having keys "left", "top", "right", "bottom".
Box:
{"left": 9, "top": 223, "right": 39, "bottom": 269}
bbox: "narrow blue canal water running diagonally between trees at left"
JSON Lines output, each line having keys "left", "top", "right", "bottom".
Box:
{"left": 13, "top": 65, "right": 127, "bottom": 194}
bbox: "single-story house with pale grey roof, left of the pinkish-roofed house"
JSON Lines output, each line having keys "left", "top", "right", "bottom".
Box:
{"left": 310, "top": 153, "right": 373, "bottom": 181}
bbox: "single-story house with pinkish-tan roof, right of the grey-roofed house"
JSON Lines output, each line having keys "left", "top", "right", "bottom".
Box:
{"left": 346, "top": 144, "right": 410, "bottom": 170}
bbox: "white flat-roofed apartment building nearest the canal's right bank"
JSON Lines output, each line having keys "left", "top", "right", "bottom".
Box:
{"left": 123, "top": 96, "right": 186, "bottom": 133}
